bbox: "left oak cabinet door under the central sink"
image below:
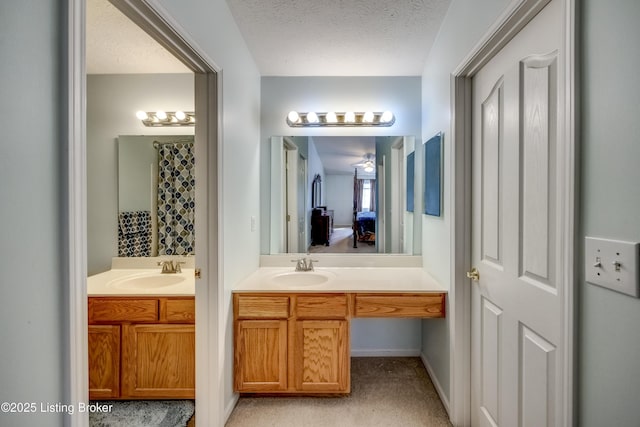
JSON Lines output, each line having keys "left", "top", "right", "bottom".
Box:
{"left": 234, "top": 320, "right": 287, "bottom": 392}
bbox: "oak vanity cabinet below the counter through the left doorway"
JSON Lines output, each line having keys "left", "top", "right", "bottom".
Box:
{"left": 89, "top": 297, "right": 195, "bottom": 399}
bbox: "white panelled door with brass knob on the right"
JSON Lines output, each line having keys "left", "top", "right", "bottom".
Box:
{"left": 471, "top": 1, "right": 566, "bottom": 427}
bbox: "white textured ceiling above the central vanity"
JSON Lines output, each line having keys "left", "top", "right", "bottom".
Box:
{"left": 227, "top": 0, "right": 450, "bottom": 76}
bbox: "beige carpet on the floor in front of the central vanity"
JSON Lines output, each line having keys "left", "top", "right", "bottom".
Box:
{"left": 226, "top": 357, "right": 451, "bottom": 427}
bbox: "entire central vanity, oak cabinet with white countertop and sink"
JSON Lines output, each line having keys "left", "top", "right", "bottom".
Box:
{"left": 233, "top": 268, "right": 446, "bottom": 394}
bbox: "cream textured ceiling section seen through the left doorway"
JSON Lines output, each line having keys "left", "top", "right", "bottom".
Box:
{"left": 86, "top": 0, "right": 191, "bottom": 74}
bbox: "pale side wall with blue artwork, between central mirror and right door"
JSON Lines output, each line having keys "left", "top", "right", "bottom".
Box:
{"left": 416, "top": 0, "right": 510, "bottom": 404}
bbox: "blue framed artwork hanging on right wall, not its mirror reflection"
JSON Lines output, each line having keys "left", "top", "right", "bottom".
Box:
{"left": 424, "top": 132, "right": 442, "bottom": 216}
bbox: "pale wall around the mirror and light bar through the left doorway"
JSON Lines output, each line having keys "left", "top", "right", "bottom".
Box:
{"left": 87, "top": 74, "right": 197, "bottom": 275}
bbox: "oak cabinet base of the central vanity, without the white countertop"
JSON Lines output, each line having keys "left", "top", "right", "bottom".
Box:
{"left": 233, "top": 292, "right": 446, "bottom": 394}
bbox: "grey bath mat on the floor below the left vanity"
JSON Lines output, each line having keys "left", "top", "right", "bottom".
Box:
{"left": 89, "top": 400, "right": 195, "bottom": 427}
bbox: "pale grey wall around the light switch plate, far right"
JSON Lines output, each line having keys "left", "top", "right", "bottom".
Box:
{"left": 577, "top": 0, "right": 640, "bottom": 427}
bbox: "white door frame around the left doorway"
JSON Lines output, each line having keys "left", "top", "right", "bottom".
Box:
{"left": 64, "top": 0, "right": 225, "bottom": 427}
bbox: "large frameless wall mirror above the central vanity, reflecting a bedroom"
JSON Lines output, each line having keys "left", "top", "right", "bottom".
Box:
{"left": 270, "top": 136, "right": 420, "bottom": 254}
